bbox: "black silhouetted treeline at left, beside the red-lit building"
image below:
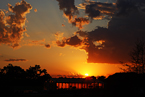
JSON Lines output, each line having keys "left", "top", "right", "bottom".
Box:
{"left": 0, "top": 64, "right": 51, "bottom": 94}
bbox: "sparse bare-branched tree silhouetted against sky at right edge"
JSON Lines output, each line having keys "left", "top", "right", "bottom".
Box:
{"left": 121, "top": 41, "right": 145, "bottom": 73}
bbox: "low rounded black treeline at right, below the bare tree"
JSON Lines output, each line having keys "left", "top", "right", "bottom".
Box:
{"left": 102, "top": 72, "right": 145, "bottom": 97}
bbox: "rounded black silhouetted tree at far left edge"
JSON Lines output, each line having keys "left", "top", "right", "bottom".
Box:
{"left": 0, "top": 64, "right": 25, "bottom": 93}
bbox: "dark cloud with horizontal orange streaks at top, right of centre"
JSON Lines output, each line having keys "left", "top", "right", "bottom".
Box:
{"left": 81, "top": 1, "right": 116, "bottom": 19}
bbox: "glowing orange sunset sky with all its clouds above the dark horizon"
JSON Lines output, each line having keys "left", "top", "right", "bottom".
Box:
{"left": 0, "top": 0, "right": 145, "bottom": 76}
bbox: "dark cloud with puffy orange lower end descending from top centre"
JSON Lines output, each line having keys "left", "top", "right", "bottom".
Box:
{"left": 57, "top": 0, "right": 89, "bottom": 29}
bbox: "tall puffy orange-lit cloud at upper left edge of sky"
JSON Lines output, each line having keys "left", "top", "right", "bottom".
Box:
{"left": 0, "top": 0, "right": 32, "bottom": 48}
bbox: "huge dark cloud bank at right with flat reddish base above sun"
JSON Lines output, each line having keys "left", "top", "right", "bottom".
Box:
{"left": 57, "top": 0, "right": 145, "bottom": 63}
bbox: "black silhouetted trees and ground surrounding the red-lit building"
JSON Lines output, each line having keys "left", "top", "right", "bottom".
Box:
{"left": 0, "top": 64, "right": 145, "bottom": 97}
